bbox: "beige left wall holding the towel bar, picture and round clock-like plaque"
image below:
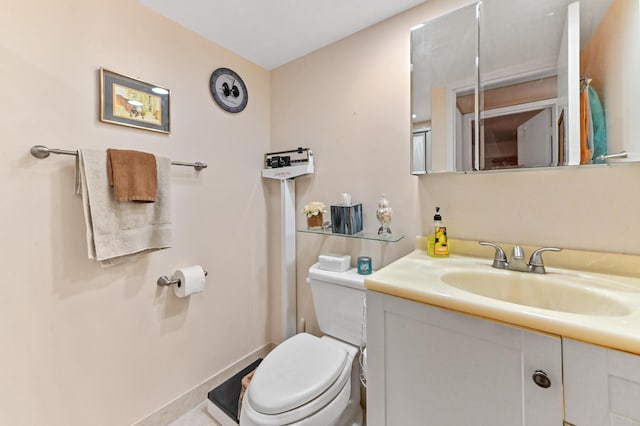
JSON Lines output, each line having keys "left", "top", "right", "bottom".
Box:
{"left": 0, "top": 0, "right": 272, "bottom": 426}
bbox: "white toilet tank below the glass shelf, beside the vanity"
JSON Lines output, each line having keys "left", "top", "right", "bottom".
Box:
{"left": 307, "top": 263, "right": 365, "bottom": 346}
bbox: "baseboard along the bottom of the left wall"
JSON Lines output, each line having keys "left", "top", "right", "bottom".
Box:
{"left": 132, "top": 343, "right": 275, "bottom": 426}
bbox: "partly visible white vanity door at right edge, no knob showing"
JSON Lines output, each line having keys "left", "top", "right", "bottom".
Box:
{"left": 562, "top": 339, "right": 640, "bottom": 426}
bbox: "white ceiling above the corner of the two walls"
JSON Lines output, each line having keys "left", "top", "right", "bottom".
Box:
{"left": 137, "top": 0, "right": 427, "bottom": 70}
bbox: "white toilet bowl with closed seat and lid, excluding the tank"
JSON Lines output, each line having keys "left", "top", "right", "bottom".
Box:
{"left": 241, "top": 333, "right": 354, "bottom": 426}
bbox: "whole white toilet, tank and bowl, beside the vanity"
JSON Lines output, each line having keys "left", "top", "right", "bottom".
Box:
{"left": 240, "top": 264, "right": 365, "bottom": 426}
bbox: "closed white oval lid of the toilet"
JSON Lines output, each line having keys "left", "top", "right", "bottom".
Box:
{"left": 247, "top": 333, "right": 348, "bottom": 414}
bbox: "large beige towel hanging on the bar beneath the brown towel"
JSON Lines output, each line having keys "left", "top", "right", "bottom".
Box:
{"left": 76, "top": 149, "right": 171, "bottom": 266}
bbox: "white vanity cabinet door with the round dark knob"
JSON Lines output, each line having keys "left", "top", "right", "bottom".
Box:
{"left": 367, "top": 292, "right": 563, "bottom": 426}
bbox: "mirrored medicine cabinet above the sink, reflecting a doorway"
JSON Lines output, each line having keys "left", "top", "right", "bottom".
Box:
{"left": 411, "top": 0, "right": 640, "bottom": 174}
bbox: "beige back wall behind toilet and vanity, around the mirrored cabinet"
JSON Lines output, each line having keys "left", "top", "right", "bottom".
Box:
{"left": 270, "top": 0, "right": 640, "bottom": 342}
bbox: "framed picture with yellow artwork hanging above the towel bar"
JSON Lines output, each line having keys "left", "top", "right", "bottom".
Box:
{"left": 100, "top": 68, "right": 170, "bottom": 133}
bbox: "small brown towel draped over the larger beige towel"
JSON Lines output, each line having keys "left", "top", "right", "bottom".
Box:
{"left": 107, "top": 149, "right": 158, "bottom": 203}
